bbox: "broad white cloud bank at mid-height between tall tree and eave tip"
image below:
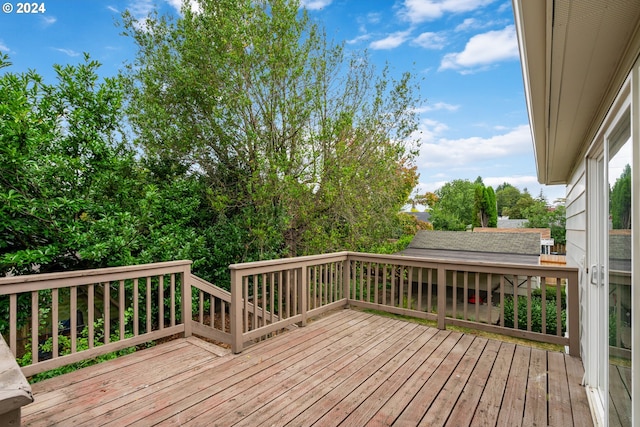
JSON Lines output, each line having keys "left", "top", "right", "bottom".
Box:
{"left": 418, "top": 120, "right": 532, "bottom": 168}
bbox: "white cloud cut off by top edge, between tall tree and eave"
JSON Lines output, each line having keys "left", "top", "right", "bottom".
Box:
{"left": 399, "top": 0, "right": 494, "bottom": 23}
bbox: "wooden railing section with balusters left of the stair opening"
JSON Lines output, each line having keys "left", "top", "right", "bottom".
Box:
{"left": 0, "top": 261, "right": 191, "bottom": 376}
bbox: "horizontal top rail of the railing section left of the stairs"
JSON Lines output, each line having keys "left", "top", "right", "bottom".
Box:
{"left": 0, "top": 260, "right": 192, "bottom": 295}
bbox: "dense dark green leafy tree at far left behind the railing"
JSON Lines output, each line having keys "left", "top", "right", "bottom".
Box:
{"left": 0, "top": 55, "right": 137, "bottom": 274}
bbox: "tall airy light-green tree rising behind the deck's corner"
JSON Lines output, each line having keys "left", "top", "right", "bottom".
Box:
{"left": 124, "top": 0, "right": 419, "bottom": 262}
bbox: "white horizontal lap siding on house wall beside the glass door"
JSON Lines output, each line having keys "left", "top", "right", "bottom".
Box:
{"left": 566, "top": 160, "right": 588, "bottom": 357}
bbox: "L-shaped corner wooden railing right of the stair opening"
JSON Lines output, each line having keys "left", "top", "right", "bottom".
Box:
{"left": 230, "top": 252, "right": 579, "bottom": 356}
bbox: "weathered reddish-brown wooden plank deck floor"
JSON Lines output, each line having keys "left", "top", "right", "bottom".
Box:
{"left": 22, "top": 310, "right": 592, "bottom": 427}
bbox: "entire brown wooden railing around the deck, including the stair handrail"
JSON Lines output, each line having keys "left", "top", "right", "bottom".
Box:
{"left": 0, "top": 252, "right": 579, "bottom": 382}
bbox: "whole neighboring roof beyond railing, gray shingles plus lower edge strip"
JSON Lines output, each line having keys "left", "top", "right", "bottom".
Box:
{"left": 400, "top": 230, "right": 540, "bottom": 265}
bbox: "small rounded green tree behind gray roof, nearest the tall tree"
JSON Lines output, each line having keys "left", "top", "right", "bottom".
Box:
{"left": 431, "top": 179, "right": 476, "bottom": 230}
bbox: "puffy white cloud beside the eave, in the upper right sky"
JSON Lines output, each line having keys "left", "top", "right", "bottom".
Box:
{"left": 440, "top": 25, "right": 518, "bottom": 72}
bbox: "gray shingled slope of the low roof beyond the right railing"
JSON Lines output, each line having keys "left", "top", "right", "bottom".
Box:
{"left": 408, "top": 230, "right": 540, "bottom": 255}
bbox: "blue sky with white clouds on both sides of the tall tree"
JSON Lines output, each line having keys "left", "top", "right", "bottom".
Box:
{"left": 0, "top": 0, "right": 564, "bottom": 206}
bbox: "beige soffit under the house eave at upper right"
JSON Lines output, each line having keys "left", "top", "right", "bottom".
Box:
{"left": 514, "top": 0, "right": 640, "bottom": 184}
